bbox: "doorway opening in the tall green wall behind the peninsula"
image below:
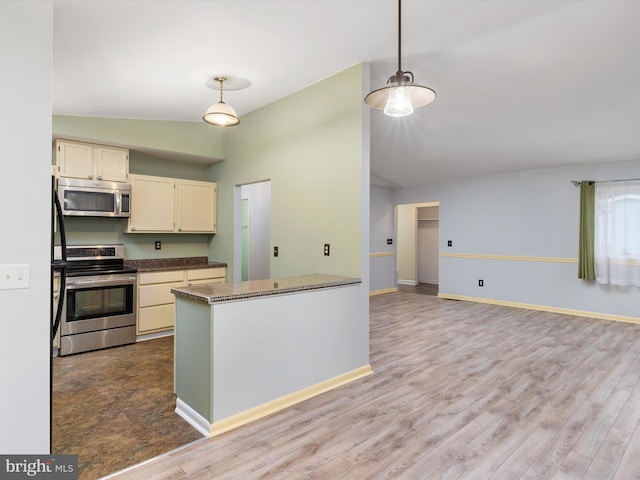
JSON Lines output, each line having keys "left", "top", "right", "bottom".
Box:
{"left": 233, "top": 180, "right": 271, "bottom": 281}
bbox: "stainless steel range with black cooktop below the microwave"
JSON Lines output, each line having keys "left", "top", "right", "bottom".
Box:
{"left": 54, "top": 245, "right": 136, "bottom": 355}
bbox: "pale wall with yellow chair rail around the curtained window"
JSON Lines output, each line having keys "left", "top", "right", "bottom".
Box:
{"left": 395, "top": 160, "right": 640, "bottom": 320}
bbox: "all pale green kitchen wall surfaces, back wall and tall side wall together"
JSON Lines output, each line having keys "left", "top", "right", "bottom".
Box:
{"left": 52, "top": 65, "right": 368, "bottom": 274}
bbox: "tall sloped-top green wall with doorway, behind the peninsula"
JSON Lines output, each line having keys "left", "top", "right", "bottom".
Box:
{"left": 209, "top": 65, "right": 368, "bottom": 278}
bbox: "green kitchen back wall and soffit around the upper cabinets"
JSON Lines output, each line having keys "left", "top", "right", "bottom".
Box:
{"left": 52, "top": 115, "right": 218, "bottom": 262}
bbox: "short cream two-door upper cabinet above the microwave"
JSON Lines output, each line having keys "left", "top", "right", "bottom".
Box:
{"left": 55, "top": 140, "right": 129, "bottom": 182}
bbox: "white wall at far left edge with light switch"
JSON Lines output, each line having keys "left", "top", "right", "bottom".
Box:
{"left": 0, "top": 1, "right": 53, "bottom": 454}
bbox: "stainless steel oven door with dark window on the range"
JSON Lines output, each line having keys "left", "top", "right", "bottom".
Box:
{"left": 60, "top": 275, "right": 136, "bottom": 336}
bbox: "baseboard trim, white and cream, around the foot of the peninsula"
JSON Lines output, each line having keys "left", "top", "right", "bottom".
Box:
{"left": 176, "top": 365, "right": 373, "bottom": 438}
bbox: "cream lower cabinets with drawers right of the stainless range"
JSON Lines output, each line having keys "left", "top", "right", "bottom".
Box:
{"left": 136, "top": 267, "right": 227, "bottom": 335}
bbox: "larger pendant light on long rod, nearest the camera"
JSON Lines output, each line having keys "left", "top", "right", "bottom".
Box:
{"left": 364, "top": 0, "right": 436, "bottom": 117}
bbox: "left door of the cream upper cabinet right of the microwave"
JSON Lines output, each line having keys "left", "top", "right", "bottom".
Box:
{"left": 127, "top": 175, "right": 176, "bottom": 233}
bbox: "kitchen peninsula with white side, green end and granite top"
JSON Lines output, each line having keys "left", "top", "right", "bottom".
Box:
{"left": 171, "top": 274, "right": 372, "bottom": 437}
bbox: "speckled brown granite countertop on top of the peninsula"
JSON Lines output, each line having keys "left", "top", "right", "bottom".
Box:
{"left": 171, "top": 273, "right": 362, "bottom": 304}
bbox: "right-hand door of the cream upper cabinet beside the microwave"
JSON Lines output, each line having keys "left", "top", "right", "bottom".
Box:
{"left": 178, "top": 180, "right": 217, "bottom": 233}
